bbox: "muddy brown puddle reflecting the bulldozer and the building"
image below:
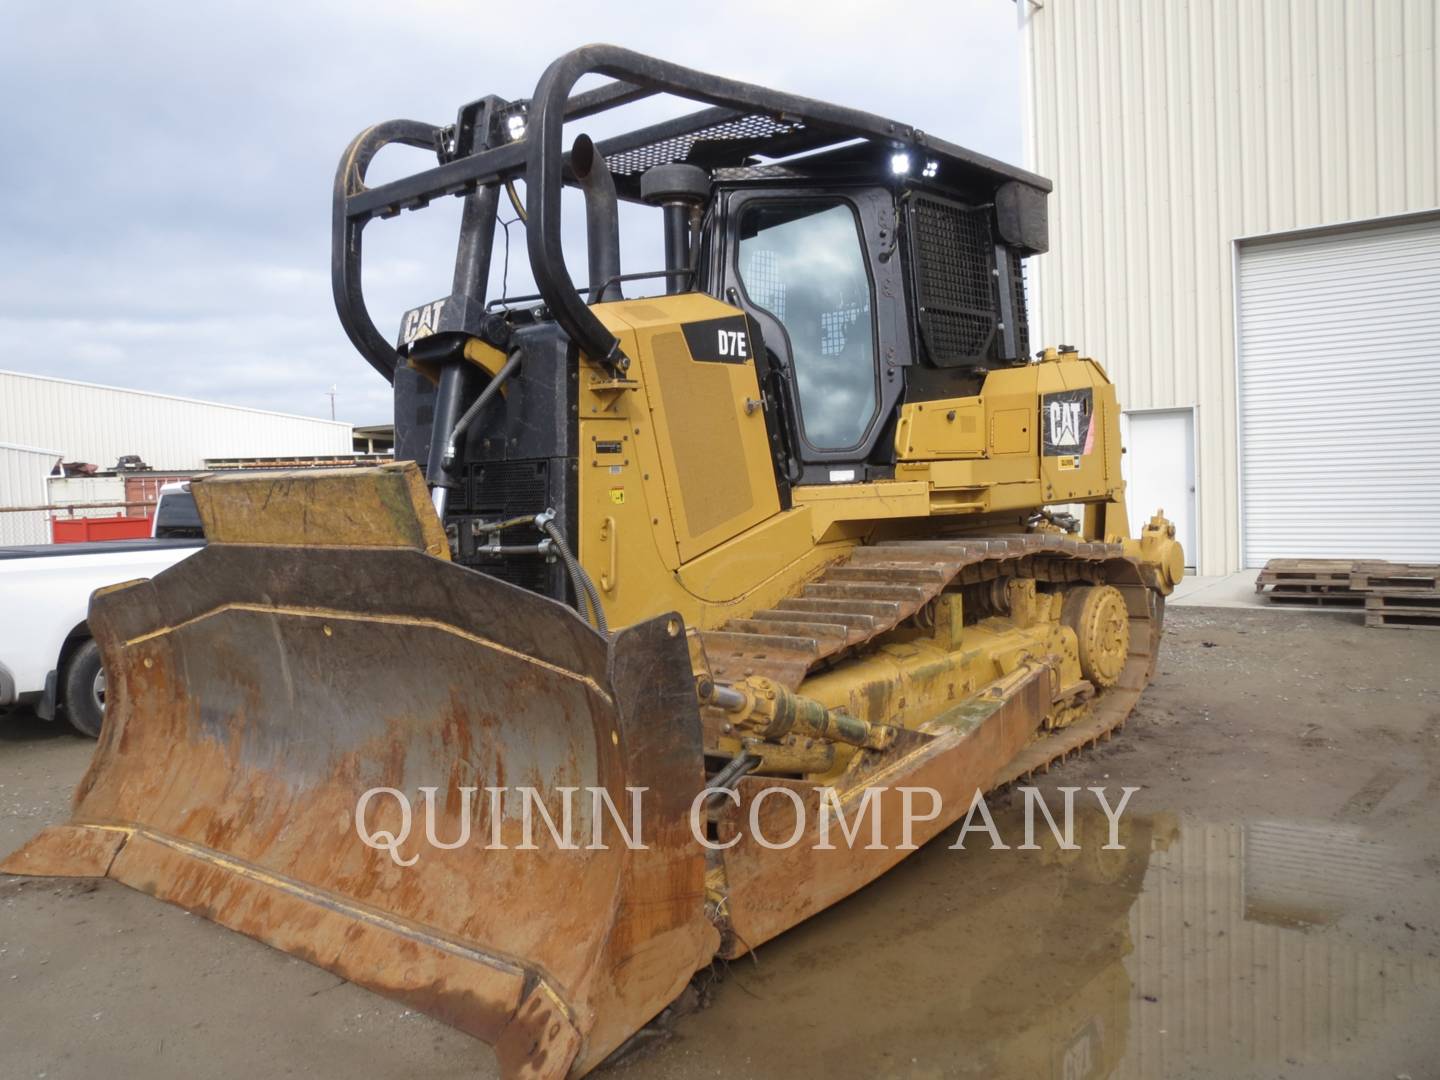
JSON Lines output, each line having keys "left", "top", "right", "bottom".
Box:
{"left": 624, "top": 799, "right": 1440, "bottom": 1080}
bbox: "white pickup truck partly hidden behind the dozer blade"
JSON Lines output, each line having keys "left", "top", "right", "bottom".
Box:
{"left": 0, "top": 484, "right": 204, "bottom": 739}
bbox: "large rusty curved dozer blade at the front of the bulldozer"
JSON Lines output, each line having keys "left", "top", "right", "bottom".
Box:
{"left": 0, "top": 467, "right": 717, "bottom": 1077}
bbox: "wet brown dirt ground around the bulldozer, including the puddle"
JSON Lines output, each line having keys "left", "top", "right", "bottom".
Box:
{"left": 0, "top": 608, "right": 1440, "bottom": 1080}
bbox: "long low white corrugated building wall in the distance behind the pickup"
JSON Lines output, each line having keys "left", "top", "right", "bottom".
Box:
{"left": 0, "top": 372, "right": 353, "bottom": 469}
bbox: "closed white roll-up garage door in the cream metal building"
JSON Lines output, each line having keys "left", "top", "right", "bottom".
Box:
{"left": 1237, "top": 217, "right": 1440, "bottom": 566}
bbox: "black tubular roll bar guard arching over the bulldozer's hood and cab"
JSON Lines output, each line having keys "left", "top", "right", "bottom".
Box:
{"left": 331, "top": 45, "right": 1050, "bottom": 379}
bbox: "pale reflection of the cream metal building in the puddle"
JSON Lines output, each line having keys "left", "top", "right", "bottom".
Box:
{"left": 1111, "top": 822, "right": 1440, "bottom": 1077}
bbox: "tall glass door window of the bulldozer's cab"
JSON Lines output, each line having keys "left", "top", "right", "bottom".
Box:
{"left": 739, "top": 200, "right": 877, "bottom": 451}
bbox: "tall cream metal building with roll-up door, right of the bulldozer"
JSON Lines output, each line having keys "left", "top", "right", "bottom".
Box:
{"left": 1018, "top": 0, "right": 1440, "bottom": 573}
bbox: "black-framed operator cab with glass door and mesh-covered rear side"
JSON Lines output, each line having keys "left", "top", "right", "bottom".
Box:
{"left": 701, "top": 144, "right": 1043, "bottom": 484}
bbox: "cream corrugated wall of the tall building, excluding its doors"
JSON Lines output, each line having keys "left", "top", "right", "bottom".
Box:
{"left": 1020, "top": 0, "right": 1440, "bottom": 573}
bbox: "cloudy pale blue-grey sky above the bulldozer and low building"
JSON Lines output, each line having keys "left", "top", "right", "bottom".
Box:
{"left": 0, "top": 0, "right": 1021, "bottom": 423}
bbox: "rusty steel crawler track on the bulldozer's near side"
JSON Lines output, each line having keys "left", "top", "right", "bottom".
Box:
{"left": 700, "top": 534, "right": 1165, "bottom": 788}
